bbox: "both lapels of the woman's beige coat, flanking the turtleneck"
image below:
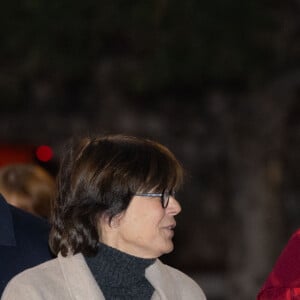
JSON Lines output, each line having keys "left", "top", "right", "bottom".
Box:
{"left": 58, "top": 253, "right": 178, "bottom": 300}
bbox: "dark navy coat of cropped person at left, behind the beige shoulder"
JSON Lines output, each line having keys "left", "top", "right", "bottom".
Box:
{"left": 0, "top": 195, "right": 54, "bottom": 295}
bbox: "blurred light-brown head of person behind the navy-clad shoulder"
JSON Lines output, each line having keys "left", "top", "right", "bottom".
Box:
{"left": 0, "top": 163, "right": 55, "bottom": 219}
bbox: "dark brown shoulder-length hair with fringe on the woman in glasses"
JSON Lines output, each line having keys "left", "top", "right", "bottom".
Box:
{"left": 50, "top": 135, "right": 183, "bottom": 256}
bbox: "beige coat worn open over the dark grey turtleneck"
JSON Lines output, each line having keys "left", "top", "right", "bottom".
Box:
{"left": 1, "top": 254, "right": 206, "bottom": 300}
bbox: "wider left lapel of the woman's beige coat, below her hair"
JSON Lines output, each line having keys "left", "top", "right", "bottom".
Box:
{"left": 58, "top": 253, "right": 105, "bottom": 300}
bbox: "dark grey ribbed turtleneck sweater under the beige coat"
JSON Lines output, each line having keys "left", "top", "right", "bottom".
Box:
{"left": 85, "top": 243, "right": 155, "bottom": 300}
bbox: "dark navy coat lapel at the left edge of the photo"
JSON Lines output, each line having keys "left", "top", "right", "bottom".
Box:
{"left": 0, "top": 195, "right": 16, "bottom": 247}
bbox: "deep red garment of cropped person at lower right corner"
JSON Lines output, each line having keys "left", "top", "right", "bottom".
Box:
{"left": 257, "top": 229, "right": 300, "bottom": 300}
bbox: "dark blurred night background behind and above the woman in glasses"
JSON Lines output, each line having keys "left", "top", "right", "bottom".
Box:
{"left": 0, "top": 0, "right": 300, "bottom": 300}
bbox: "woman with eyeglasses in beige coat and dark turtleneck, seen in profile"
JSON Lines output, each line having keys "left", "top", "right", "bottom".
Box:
{"left": 1, "top": 135, "right": 206, "bottom": 300}
